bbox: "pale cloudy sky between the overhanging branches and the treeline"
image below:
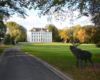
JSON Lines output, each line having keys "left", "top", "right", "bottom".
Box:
{"left": 7, "top": 10, "right": 92, "bottom": 30}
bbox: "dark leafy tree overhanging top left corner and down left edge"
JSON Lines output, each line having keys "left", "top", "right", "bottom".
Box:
{"left": 0, "top": 0, "right": 33, "bottom": 39}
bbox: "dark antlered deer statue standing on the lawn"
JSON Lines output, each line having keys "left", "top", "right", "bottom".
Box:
{"left": 70, "top": 43, "right": 94, "bottom": 69}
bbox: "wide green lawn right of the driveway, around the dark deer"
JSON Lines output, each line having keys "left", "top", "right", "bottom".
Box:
{"left": 20, "top": 43, "right": 100, "bottom": 80}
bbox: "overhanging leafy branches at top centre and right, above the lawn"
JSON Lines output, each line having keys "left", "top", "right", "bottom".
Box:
{"left": 34, "top": 0, "right": 100, "bottom": 26}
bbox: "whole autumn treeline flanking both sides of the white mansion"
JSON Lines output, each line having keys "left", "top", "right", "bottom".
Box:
{"left": 5, "top": 21, "right": 100, "bottom": 47}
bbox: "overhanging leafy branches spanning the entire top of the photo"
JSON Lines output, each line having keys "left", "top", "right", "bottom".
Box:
{"left": 0, "top": 0, "right": 100, "bottom": 26}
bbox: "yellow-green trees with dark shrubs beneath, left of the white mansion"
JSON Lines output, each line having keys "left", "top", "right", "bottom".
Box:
{"left": 5, "top": 21, "right": 27, "bottom": 44}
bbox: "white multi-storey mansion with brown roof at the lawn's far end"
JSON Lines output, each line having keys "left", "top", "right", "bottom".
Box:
{"left": 27, "top": 28, "right": 52, "bottom": 42}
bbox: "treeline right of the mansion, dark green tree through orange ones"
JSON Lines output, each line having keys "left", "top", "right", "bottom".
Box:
{"left": 45, "top": 24, "right": 100, "bottom": 46}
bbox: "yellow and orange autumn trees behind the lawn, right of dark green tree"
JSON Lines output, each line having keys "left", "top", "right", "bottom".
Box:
{"left": 60, "top": 25, "right": 100, "bottom": 47}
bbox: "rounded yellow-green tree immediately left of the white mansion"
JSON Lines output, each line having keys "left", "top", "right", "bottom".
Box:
{"left": 6, "top": 21, "right": 26, "bottom": 42}
